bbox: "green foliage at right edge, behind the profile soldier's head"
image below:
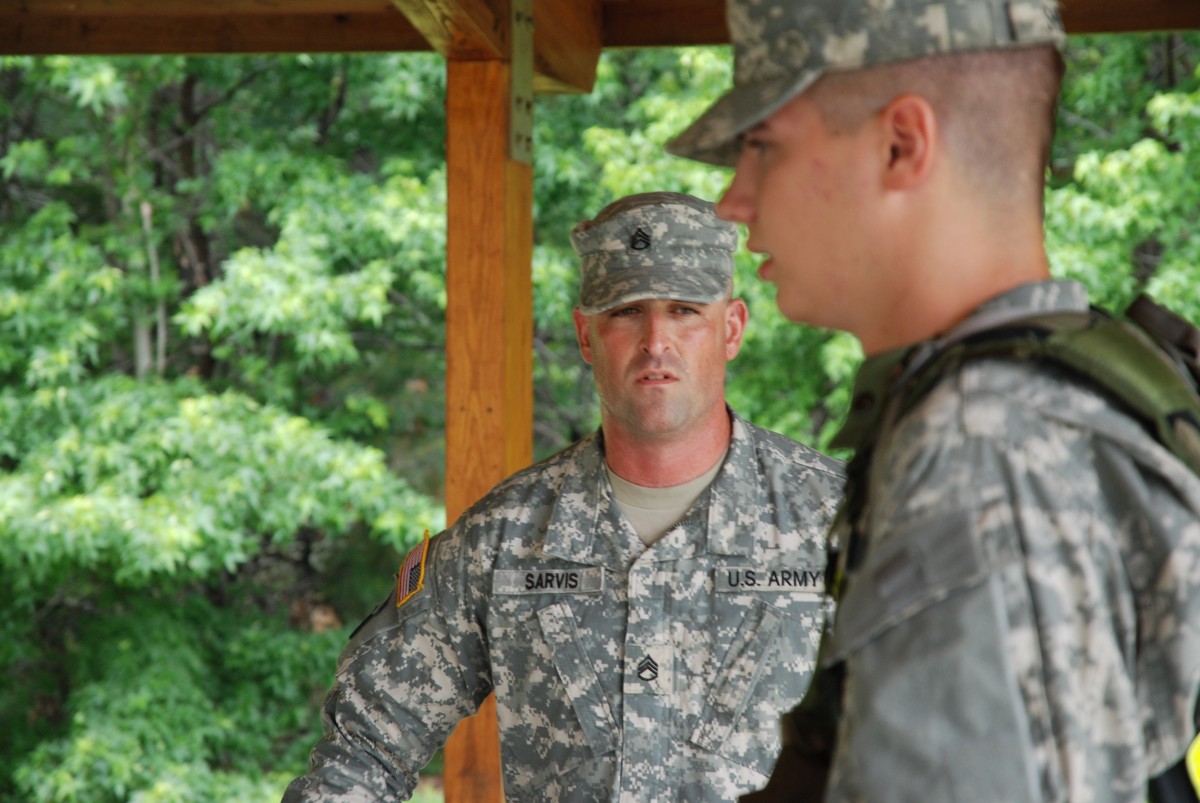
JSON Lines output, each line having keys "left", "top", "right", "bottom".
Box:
{"left": 1046, "top": 34, "right": 1200, "bottom": 320}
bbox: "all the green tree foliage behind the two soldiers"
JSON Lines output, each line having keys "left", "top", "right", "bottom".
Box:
{"left": 0, "top": 29, "right": 1200, "bottom": 802}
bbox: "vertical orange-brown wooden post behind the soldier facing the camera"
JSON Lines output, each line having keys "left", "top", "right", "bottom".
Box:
{"left": 444, "top": 59, "right": 533, "bottom": 803}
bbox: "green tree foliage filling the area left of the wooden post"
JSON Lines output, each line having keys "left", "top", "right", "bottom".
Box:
{"left": 0, "top": 56, "right": 445, "bottom": 801}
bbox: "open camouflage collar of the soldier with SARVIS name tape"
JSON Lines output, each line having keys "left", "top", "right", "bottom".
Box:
{"left": 542, "top": 409, "right": 767, "bottom": 564}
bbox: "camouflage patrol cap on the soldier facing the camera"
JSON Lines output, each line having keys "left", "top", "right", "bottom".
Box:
{"left": 571, "top": 192, "right": 738, "bottom": 314}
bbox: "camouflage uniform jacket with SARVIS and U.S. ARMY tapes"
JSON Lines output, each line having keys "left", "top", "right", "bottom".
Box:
{"left": 283, "top": 410, "right": 841, "bottom": 803}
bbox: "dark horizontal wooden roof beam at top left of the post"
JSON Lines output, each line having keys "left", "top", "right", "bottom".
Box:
{"left": 0, "top": 8, "right": 430, "bottom": 55}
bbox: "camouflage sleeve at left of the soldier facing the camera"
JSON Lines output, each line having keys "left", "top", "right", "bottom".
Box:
{"left": 283, "top": 531, "right": 491, "bottom": 803}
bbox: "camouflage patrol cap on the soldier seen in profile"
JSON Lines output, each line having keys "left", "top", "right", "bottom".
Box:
{"left": 666, "top": 0, "right": 1064, "bottom": 166}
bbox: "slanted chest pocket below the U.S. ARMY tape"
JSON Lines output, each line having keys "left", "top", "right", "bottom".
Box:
{"left": 690, "top": 601, "right": 787, "bottom": 774}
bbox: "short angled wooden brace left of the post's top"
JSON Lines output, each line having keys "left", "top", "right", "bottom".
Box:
{"left": 392, "top": 0, "right": 509, "bottom": 59}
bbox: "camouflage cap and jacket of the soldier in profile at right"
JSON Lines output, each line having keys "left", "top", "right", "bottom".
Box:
{"left": 667, "top": 0, "right": 1200, "bottom": 803}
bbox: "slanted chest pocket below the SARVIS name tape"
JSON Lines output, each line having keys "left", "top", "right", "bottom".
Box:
{"left": 538, "top": 603, "right": 617, "bottom": 755}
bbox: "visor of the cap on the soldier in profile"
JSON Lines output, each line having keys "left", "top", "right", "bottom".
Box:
{"left": 666, "top": 70, "right": 823, "bottom": 167}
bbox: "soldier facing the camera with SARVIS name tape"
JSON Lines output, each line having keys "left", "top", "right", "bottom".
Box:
{"left": 283, "top": 193, "right": 844, "bottom": 803}
